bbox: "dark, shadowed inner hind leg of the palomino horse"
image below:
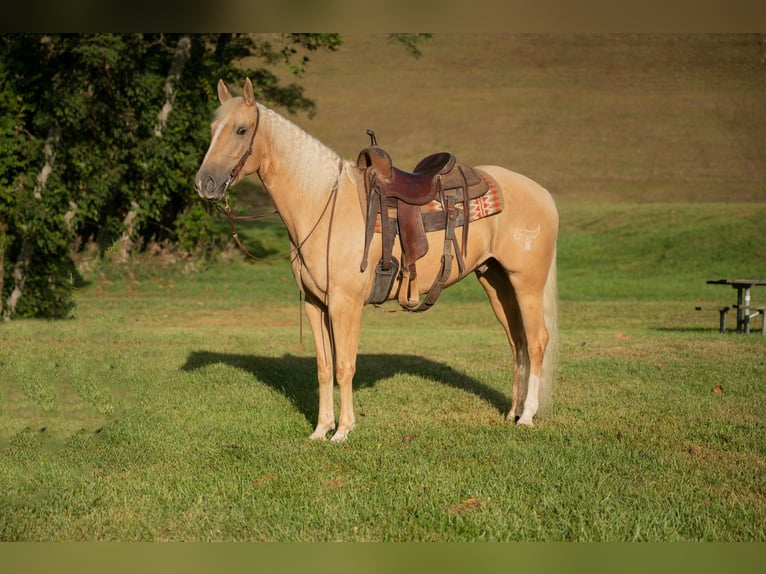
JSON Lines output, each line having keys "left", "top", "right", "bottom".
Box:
{"left": 476, "top": 259, "right": 529, "bottom": 421}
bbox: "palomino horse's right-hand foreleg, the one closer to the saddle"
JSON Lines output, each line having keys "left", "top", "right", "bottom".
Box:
{"left": 330, "top": 300, "right": 362, "bottom": 442}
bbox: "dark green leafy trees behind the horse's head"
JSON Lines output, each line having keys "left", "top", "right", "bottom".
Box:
{"left": 0, "top": 34, "right": 341, "bottom": 319}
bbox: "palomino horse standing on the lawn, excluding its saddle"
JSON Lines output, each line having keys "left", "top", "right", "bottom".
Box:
{"left": 194, "top": 79, "right": 558, "bottom": 442}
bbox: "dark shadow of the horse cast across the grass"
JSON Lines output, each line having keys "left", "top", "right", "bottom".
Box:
{"left": 181, "top": 351, "right": 511, "bottom": 424}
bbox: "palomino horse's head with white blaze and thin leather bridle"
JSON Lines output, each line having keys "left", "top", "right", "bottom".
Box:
{"left": 194, "top": 78, "right": 259, "bottom": 200}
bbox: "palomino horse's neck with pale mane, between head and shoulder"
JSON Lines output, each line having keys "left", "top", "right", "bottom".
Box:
{"left": 256, "top": 105, "right": 343, "bottom": 235}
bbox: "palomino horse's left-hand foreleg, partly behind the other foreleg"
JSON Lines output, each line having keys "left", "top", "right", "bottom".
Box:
{"left": 305, "top": 295, "right": 335, "bottom": 440}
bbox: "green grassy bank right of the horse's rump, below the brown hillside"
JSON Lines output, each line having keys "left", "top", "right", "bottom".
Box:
{"left": 560, "top": 203, "right": 766, "bottom": 302}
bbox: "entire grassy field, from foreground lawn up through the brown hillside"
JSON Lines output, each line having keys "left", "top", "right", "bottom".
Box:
{"left": 0, "top": 36, "right": 766, "bottom": 542}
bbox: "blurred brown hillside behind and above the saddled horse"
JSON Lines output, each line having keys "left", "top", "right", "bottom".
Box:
{"left": 240, "top": 34, "right": 766, "bottom": 202}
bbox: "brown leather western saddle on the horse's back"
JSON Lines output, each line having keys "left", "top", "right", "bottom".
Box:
{"left": 357, "top": 130, "right": 489, "bottom": 312}
